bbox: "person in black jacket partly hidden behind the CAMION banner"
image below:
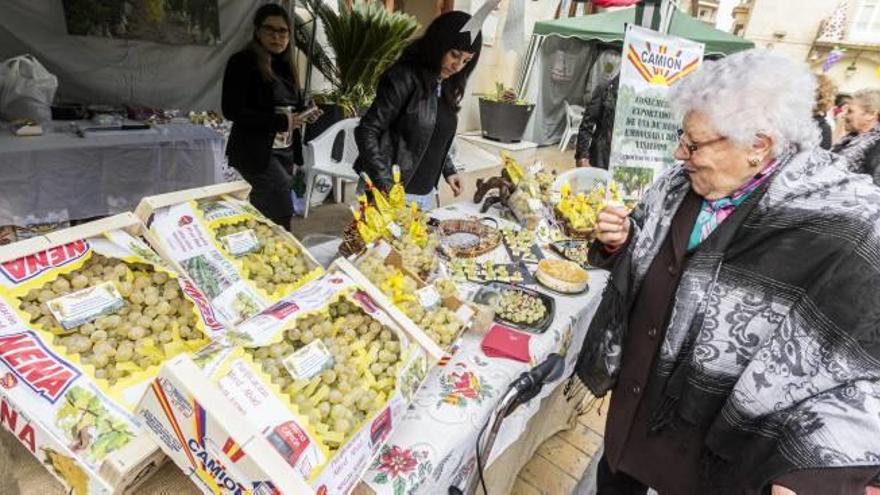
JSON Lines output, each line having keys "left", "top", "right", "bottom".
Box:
{"left": 574, "top": 74, "right": 620, "bottom": 170}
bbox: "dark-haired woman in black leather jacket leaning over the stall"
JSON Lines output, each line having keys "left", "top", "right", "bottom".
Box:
{"left": 355, "top": 11, "right": 483, "bottom": 209}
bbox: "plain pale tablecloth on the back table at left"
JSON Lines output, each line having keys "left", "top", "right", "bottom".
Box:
{"left": 0, "top": 122, "right": 224, "bottom": 226}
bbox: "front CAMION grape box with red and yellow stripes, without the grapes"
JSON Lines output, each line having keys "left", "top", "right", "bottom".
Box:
{"left": 138, "top": 269, "right": 427, "bottom": 494}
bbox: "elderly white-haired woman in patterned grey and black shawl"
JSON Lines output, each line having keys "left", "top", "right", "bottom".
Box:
{"left": 576, "top": 50, "right": 880, "bottom": 495}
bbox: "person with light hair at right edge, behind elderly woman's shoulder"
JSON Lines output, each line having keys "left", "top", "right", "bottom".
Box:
{"left": 832, "top": 89, "right": 880, "bottom": 184}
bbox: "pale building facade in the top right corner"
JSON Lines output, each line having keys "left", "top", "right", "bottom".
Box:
{"left": 733, "top": 0, "right": 880, "bottom": 92}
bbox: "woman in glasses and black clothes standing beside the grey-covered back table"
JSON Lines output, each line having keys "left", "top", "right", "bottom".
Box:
{"left": 222, "top": 4, "right": 320, "bottom": 230}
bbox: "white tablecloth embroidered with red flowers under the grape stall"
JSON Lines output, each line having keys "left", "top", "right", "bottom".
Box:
{"left": 362, "top": 203, "right": 607, "bottom": 495}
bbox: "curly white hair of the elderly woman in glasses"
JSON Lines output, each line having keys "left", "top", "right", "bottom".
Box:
{"left": 670, "top": 50, "right": 819, "bottom": 155}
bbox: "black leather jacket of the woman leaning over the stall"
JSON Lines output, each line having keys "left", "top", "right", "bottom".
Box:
{"left": 354, "top": 63, "right": 457, "bottom": 189}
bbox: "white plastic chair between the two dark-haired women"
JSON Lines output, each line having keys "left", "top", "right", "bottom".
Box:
{"left": 303, "top": 119, "right": 360, "bottom": 218}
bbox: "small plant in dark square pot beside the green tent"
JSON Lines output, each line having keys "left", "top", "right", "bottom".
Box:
{"left": 480, "top": 83, "right": 535, "bottom": 143}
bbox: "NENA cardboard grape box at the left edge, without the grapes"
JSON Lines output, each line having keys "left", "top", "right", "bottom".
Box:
{"left": 0, "top": 213, "right": 223, "bottom": 495}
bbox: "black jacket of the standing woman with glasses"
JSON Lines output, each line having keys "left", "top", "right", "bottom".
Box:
{"left": 222, "top": 49, "right": 300, "bottom": 173}
